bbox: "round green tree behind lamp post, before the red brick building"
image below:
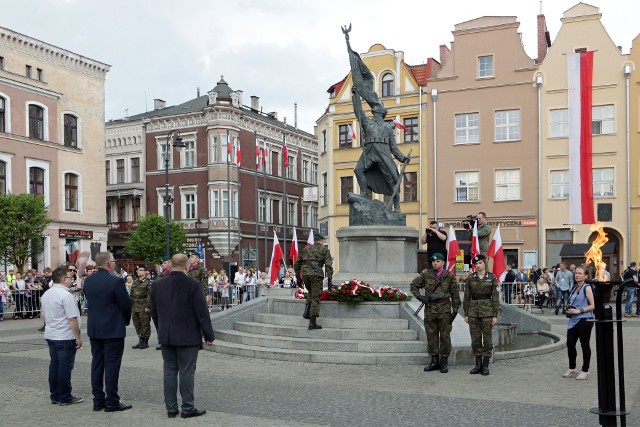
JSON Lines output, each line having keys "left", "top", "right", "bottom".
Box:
{"left": 125, "top": 214, "right": 187, "bottom": 264}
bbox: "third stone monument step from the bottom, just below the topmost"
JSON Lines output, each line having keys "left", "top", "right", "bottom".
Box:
{"left": 235, "top": 319, "right": 418, "bottom": 341}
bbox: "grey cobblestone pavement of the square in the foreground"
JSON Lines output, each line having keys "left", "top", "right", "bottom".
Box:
{"left": 0, "top": 310, "right": 640, "bottom": 427}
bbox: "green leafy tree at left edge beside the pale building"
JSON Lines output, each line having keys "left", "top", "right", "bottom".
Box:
{"left": 0, "top": 194, "right": 51, "bottom": 272}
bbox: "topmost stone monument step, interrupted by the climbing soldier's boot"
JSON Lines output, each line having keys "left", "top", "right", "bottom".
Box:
{"left": 253, "top": 310, "right": 409, "bottom": 330}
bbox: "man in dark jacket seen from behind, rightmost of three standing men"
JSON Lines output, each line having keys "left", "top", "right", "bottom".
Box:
{"left": 151, "top": 254, "right": 214, "bottom": 418}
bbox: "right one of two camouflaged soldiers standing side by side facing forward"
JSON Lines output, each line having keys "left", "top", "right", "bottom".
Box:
{"left": 462, "top": 255, "right": 500, "bottom": 375}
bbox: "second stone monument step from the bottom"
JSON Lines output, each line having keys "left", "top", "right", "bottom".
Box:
{"left": 216, "top": 330, "right": 427, "bottom": 354}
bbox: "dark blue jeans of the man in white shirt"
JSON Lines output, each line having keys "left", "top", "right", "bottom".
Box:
{"left": 47, "top": 339, "right": 76, "bottom": 403}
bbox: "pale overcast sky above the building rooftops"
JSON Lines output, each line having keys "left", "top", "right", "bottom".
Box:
{"left": 0, "top": 0, "right": 640, "bottom": 132}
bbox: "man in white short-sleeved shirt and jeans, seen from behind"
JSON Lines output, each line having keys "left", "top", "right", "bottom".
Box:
{"left": 41, "top": 266, "right": 84, "bottom": 406}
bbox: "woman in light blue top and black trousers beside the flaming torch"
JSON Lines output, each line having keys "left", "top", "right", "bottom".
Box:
{"left": 562, "top": 267, "right": 595, "bottom": 380}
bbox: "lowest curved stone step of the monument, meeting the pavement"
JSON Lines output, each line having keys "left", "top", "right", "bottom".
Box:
{"left": 208, "top": 339, "right": 429, "bottom": 365}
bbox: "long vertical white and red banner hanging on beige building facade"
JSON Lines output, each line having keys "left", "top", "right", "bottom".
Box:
{"left": 567, "top": 52, "right": 595, "bottom": 224}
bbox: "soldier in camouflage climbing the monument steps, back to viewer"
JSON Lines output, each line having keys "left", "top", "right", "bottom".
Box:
{"left": 293, "top": 231, "right": 333, "bottom": 330}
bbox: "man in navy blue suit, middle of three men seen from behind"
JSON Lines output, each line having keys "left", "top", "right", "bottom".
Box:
{"left": 84, "top": 252, "right": 131, "bottom": 412}
